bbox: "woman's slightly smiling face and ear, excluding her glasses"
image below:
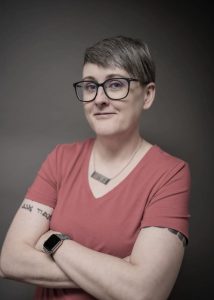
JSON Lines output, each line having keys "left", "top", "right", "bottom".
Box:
{"left": 83, "top": 63, "right": 154, "bottom": 136}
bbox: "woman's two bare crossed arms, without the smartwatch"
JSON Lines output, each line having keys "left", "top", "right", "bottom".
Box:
{"left": 1, "top": 199, "right": 184, "bottom": 300}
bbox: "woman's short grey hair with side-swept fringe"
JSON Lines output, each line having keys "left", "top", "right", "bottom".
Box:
{"left": 84, "top": 36, "right": 155, "bottom": 84}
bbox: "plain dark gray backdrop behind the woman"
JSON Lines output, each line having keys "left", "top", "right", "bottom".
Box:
{"left": 0, "top": 0, "right": 214, "bottom": 300}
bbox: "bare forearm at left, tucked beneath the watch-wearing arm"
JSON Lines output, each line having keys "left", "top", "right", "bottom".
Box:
{"left": 1, "top": 245, "right": 78, "bottom": 288}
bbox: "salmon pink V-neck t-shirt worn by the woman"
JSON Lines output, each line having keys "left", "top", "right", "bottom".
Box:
{"left": 26, "top": 139, "right": 190, "bottom": 300}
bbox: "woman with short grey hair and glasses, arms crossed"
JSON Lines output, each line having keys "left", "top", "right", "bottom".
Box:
{"left": 1, "top": 36, "right": 190, "bottom": 300}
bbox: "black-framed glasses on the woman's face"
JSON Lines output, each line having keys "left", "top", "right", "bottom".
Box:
{"left": 73, "top": 77, "right": 139, "bottom": 102}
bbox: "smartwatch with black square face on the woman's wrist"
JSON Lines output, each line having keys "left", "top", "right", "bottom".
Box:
{"left": 43, "top": 233, "right": 71, "bottom": 255}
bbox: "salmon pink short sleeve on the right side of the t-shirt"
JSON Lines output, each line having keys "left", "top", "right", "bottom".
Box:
{"left": 141, "top": 161, "right": 191, "bottom": 238}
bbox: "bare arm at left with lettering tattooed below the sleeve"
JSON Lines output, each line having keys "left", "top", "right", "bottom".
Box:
{"left": 0, "top": 199, "right": 78, "bottom": 288}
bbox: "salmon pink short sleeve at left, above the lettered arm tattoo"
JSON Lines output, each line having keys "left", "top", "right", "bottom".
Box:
{"left": 25, "top": 146, "right": 58, "bottom": 208}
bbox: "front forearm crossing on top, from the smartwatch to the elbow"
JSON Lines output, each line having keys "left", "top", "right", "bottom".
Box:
{"left": 54, "top": 241, "right": 143, "bottom": 300}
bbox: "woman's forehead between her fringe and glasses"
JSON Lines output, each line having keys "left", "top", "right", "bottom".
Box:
{"left": 83, "top": 63, "right": 129, "bottom": 80}
